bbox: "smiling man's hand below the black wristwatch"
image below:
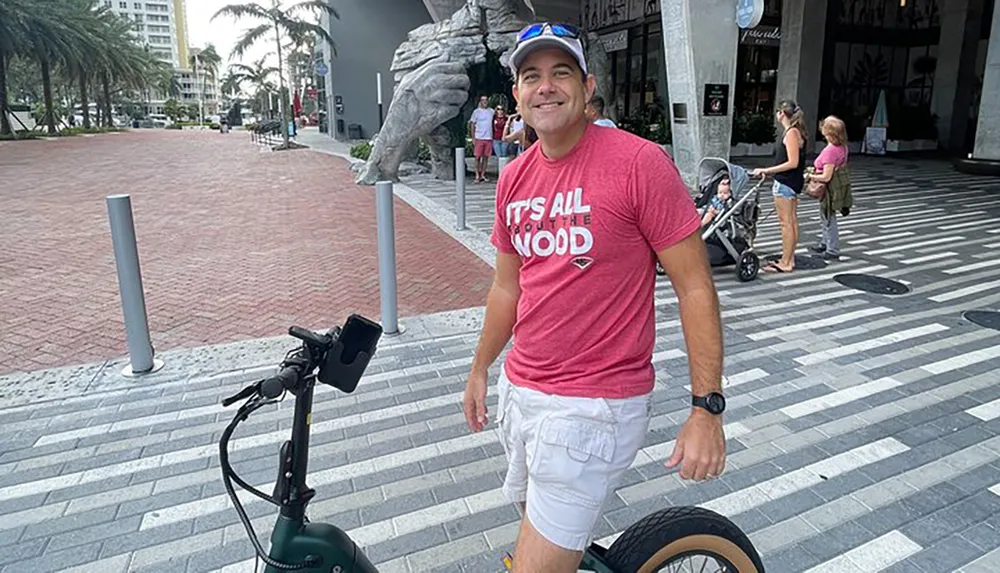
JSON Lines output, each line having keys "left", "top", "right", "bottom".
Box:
{"left": 666, "top": 408, "right": 726, "bottom": 481}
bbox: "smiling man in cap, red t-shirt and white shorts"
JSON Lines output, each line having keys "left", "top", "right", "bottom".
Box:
{"left": 464, "top": 23, "right": 725, "bottom": 573}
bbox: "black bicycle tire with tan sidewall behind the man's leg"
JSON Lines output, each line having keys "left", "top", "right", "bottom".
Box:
{"left": 604, "top": 507, "right": 764, "bottom": 573}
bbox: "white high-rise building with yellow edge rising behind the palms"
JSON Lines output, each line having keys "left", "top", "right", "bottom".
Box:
{"left": 100, "top": 0, "right": 188, "bottom": 67}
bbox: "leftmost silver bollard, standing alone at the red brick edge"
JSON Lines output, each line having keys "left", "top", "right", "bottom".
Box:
{"left": 105, "top": 195, "right": 163, "bottom": 377}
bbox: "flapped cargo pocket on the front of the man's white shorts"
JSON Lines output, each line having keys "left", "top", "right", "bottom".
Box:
{"left": 530, "top": 416, "right": 615, "bottom": 507}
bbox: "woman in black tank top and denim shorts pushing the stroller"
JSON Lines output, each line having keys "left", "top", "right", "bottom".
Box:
{"left": 751, "top": 100, "right": 808, "bottom": 273}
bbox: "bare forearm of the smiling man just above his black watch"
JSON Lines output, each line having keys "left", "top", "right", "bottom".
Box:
{"left": 678, "top": 284, "right": 723, "bottom": 396}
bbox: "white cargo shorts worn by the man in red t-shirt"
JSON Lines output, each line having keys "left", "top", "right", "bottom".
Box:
{"left": 497, "top": 370, "right": 650, "bottom": 551}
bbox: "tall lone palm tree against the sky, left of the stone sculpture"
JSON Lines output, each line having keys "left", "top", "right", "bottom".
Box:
{"left": 212, "top": 0, "right": 340, "bottom": 148}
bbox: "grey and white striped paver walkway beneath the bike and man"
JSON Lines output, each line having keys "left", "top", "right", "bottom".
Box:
{"left": 0, "top": 149, "right": 1000, "bottom": 573}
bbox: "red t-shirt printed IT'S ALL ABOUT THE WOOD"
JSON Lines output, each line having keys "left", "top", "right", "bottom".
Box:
{"left": 491, "top": 124, "right": 701, "bottom": 398}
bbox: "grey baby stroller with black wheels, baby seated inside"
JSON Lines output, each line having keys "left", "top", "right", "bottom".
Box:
{"left": 695, "top": 157, "right": 764, "bottom": 282}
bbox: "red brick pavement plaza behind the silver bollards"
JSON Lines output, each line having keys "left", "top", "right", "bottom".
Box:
{"left": 0, "top": 130, "right": 491, "bottom": 373}
